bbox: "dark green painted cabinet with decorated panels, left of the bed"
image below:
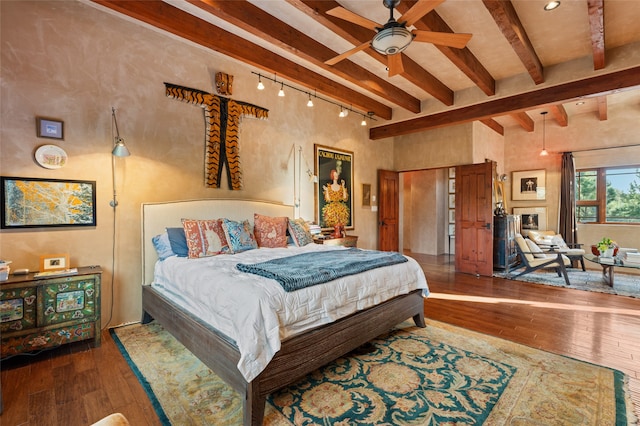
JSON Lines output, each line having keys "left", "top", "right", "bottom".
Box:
{"left": 0, "top": 266, "right": 102, "bottom": 358}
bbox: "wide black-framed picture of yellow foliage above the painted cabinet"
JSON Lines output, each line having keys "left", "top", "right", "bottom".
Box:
{"left": 0, "top": 176, "right": 96, "bottom": 228}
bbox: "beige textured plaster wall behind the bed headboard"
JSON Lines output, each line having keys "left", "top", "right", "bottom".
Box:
{"left": 0, "top": 1, "right": 393, "bottom": 325}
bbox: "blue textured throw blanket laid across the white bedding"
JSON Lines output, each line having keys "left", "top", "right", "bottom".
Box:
{"left": 236, "top": 248, "right": 407, "bottom": 291}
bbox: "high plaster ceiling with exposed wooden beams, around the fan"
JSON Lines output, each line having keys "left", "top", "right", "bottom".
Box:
{"left": 93, "top": 0, "right": 640, "bottom": 139}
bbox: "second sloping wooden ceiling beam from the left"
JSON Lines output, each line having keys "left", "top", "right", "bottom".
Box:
{"left": 189, "top": 0, "right": 421, "bottom": 113}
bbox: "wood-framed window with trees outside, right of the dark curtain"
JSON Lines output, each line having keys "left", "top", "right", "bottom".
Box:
{"left": 576, "top": 167, "right": 640, "bottom": 224}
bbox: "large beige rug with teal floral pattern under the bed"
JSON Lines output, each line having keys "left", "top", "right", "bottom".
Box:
{"left": 111, "top": 320, "right": 635, "bottom": 426}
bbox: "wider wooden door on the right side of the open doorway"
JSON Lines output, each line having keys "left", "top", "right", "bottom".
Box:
{"left": 455, "top": 162, "right": 495, "bottom": 277}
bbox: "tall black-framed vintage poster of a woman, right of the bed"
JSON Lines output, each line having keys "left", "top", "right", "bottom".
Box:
{"left": 314, "top": 144, "right": 353, "bottom": 231}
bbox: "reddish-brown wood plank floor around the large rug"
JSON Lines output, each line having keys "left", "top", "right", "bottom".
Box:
{"left": 0, "top": 255, "right": 640, "bottom": 426}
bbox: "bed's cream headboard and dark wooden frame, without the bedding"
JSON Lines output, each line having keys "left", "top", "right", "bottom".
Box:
{"left": 142, "top": 199, "right": 428, "bottom": 425}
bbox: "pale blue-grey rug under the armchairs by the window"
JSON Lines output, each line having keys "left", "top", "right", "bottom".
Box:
{"left": 493, "top": 267, "right": 640, "bottom": 297}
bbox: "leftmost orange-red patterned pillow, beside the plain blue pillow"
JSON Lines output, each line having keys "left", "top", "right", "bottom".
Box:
{"left": 182, "top": 219, "right": 229, "bottom": 259}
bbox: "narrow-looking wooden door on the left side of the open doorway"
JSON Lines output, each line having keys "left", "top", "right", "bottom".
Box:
{"left": 378, "top": 170, "right": 400, "bottom": 251}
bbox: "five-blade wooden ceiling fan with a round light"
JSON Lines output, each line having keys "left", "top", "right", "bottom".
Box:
{"left": 325, "top": 0, "right": 472, "bottom": 77}
